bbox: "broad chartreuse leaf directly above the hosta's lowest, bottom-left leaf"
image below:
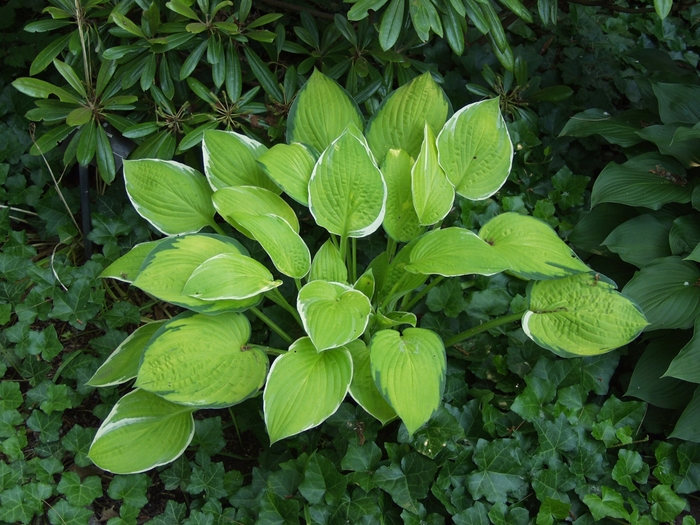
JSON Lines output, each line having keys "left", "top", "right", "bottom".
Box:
{"left": 136, "top": 312, "right": 268, "bottom": 408}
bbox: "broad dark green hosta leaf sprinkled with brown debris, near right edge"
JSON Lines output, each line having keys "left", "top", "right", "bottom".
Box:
{"left": 591, "top": 153, "right": 693, "bottom": 210}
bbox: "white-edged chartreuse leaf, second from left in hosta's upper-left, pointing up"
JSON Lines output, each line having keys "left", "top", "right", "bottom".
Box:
{"left": 202, "top": 130, "right": 281, "bottom": 194}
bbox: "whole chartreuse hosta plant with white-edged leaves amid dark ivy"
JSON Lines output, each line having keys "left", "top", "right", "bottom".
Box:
{"left": 90, "top": 72, "right": 647, "bottom": 473}
